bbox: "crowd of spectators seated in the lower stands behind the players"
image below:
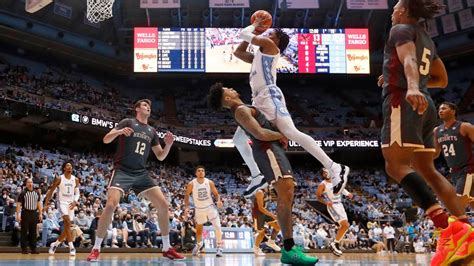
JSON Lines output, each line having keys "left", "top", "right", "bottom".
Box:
{"left": 0, "top": 145, "right": 466, "bottom": 252}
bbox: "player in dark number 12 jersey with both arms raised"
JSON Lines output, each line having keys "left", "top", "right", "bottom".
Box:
{"left": 87, "top": 99, "right": 184, "bottom": 261}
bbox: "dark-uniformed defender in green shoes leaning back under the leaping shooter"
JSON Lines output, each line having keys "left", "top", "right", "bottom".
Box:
{"left": 208, "top": 83, "right": 318, "bottom": 265}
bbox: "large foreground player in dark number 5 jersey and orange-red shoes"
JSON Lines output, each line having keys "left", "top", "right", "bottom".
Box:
{"left": 378, "top": 0, "right": 472, "bottom": 265}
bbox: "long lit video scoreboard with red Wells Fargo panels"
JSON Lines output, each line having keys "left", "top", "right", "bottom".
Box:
{"left": 134, "top": 28, "right": 370, "bottom": 74}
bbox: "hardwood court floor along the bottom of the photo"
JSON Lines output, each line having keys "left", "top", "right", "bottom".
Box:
{"left": 0, "top": 253, "right": 473, "bottom": 266}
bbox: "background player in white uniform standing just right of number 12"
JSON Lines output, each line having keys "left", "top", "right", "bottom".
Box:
{"left": 184, "top": 165, "right": 222, "bottom": 257}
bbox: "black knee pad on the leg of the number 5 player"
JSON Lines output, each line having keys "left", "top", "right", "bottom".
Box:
{"left": 400, "top": 172, "right": 438, "bottom": 211}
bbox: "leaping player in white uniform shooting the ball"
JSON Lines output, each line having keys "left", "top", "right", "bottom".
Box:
{"left": 233, "top": 18, "right": 350, "bottom": 197}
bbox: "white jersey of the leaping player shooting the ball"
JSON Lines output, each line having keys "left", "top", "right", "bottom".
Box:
{"left": 250, "top": 48, "right": 280, "bottom": 96}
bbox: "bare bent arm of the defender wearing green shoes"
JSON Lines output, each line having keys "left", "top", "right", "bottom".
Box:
{"left": 235, "top": 105, "right": 284, "bottom": 141}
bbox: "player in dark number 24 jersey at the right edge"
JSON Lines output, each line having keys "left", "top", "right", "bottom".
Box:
{"left": 434, "top": 102, "right": 474, "bottom": 205}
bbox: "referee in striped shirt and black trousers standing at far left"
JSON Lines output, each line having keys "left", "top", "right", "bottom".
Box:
{"left": 16, "top": 178, "right": 43, "bottom": 254}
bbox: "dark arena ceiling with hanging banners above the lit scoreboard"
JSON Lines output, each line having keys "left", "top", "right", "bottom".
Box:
{"left": 0, "top": 0, "right": 396, "bottom": 50}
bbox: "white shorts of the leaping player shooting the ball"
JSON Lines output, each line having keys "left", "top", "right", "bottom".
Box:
{"left": 252, "top": 85, "right": 290, "bottom": 121}
